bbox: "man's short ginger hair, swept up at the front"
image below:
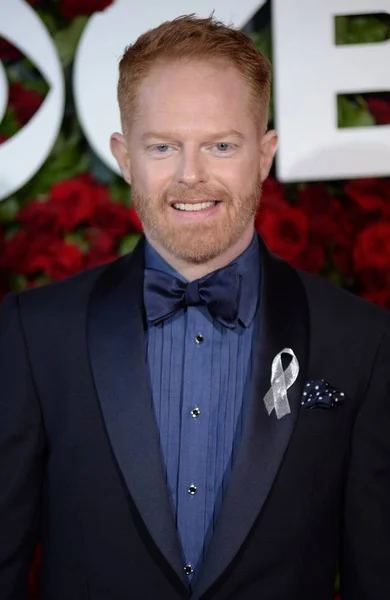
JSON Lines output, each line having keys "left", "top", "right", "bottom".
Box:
{"left": 118, "top": 14, "right": 271, "bottom": 133}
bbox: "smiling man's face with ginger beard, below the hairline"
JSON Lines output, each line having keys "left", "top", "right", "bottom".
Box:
{"left": 112, "top": 61, "right": 276, "bottom": 263}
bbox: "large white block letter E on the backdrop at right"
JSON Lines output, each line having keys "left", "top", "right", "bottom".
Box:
{"left": 272, "top": 0, "right": 390, "bottom": 181}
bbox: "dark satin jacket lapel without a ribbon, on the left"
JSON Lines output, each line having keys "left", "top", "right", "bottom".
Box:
{"left": 88, "top": 241, "right": 187, "bottom": 586}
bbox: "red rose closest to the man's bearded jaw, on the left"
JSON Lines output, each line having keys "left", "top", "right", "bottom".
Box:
{"left": 89, "top": 188, "right": 142, "bottom": 238}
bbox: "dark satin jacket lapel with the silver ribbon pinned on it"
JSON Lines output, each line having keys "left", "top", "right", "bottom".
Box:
{"left": 193, "top": 242, "right": 309, "bottom": 600}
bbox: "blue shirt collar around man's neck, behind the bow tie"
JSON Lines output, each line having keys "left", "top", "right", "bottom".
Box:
{"left": 145, "top": 233, "right": 260, "bottom": 327}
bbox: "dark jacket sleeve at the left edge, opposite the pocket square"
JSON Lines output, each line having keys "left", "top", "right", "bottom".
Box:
{"left": 0, "top": 294, "right": 44, "bottom": 600}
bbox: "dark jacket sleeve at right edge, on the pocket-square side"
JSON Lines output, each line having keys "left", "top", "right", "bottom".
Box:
{"left": 341, "top": 316, "right": 390, "bottom": 600}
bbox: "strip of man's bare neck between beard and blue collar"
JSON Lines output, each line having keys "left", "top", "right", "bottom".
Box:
{"left": 146, "top": 223, "right": 255, "bottom": 281}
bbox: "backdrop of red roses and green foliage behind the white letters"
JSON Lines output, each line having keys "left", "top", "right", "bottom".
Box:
{"left": 0, "top": 0, "right": 390, "bottom": 598}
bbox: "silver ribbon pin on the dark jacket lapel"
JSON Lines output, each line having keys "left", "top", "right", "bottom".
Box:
{"left": 264, "top": 348, "right": 299, "bottom": 419}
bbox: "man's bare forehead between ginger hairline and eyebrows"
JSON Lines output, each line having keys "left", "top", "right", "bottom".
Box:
{"left": 134, "top": 61, "right": 253, "bottom": 137}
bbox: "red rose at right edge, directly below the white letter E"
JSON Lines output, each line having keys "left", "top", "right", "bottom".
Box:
{"left": 344, "top": 179, "right": 390, "bottom": 211}
